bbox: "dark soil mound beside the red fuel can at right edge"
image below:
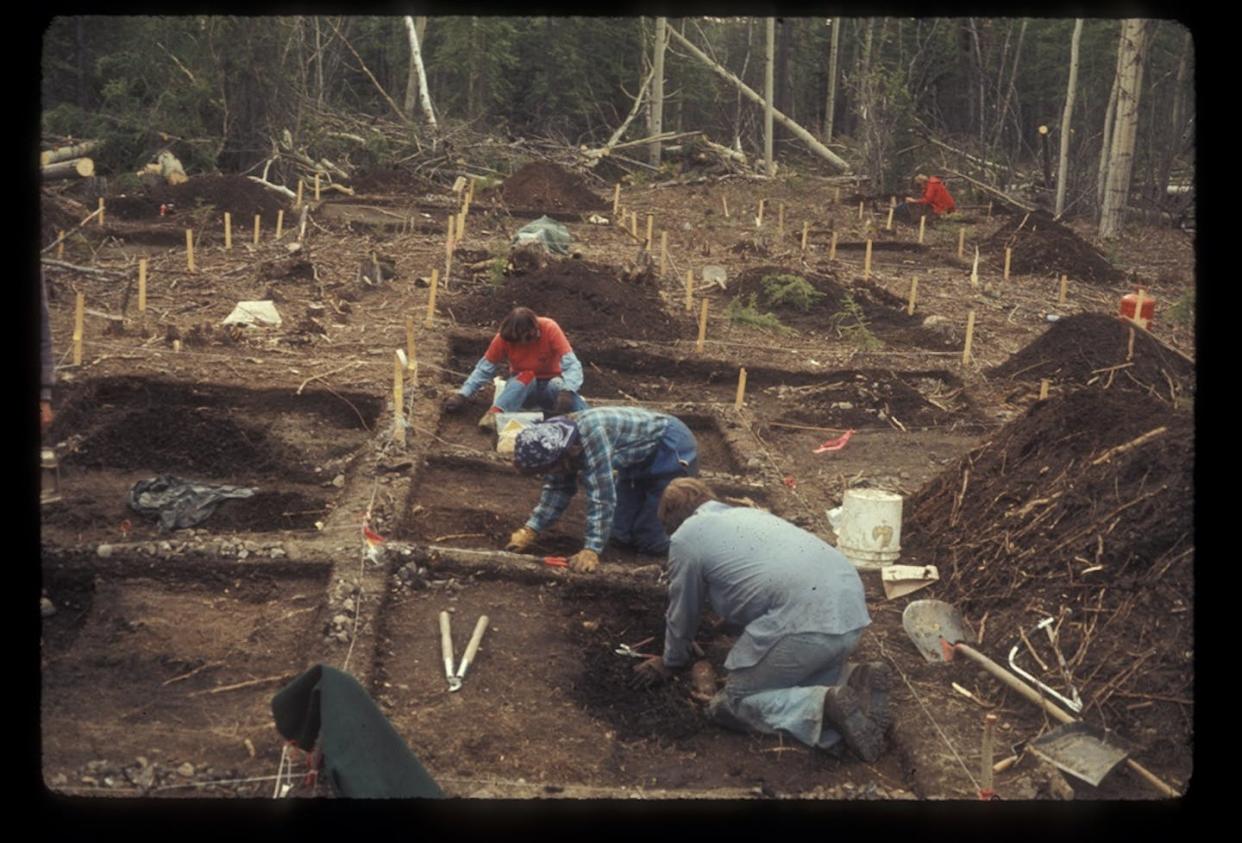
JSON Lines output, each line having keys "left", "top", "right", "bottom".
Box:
{"left": 986, "top": 313, "right": 1195, "bottom": 400}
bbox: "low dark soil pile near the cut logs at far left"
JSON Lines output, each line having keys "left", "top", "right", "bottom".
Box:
{"left": 107, "top": 175, "right": 288, "bottom": 227}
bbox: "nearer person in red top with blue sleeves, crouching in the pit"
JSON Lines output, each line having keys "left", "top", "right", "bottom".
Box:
{"left": 445, "top": 308, "right": 587, "bottom": 430}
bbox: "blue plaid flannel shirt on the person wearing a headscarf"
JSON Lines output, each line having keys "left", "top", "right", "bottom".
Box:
{"left": 527, "top": 407, "right": 669, "bottom": 552}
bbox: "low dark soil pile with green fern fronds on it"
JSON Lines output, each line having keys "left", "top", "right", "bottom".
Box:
{"left": 728, "top": 266, "right": 960, "bottom": 351}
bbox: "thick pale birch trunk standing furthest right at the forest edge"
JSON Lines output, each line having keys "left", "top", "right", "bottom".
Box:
{"left": 1099, "top": 19, "right": 1150, "bottom": 238}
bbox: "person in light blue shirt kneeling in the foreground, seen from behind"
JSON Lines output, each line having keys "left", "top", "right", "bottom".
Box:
{"left": 635, "top": 478, "right": 892, "bottom": 762}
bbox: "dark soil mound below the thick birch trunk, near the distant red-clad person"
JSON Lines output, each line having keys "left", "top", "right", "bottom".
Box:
{"left": 980, "top": 211, "right": 1125, "bottom": 284}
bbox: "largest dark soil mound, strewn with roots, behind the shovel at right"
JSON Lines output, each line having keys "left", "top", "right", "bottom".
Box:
{"left": 902, "top": 390, "right": 1195, "bottom": 747}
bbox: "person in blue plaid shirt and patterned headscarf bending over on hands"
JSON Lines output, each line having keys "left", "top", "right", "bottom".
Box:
{"left": 505, "top": 407, "right": 698, "bottom": 574}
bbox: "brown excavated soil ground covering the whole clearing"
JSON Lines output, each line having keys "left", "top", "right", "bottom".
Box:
{"left": 40, "top": 165, "right": 1195, "bottom": 800}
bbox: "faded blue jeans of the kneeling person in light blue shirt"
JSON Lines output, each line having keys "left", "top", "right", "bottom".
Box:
{"left": 708, "top": 629, "right": 862, "bottom": 749}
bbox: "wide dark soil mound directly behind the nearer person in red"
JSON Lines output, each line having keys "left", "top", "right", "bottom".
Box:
{"left": 453, "top": 259, "right": 682, "bottom": 343}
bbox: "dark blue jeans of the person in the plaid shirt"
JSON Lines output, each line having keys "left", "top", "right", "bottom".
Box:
{"left": 611, "top": 418, "right": 698, "bottom": 556}
